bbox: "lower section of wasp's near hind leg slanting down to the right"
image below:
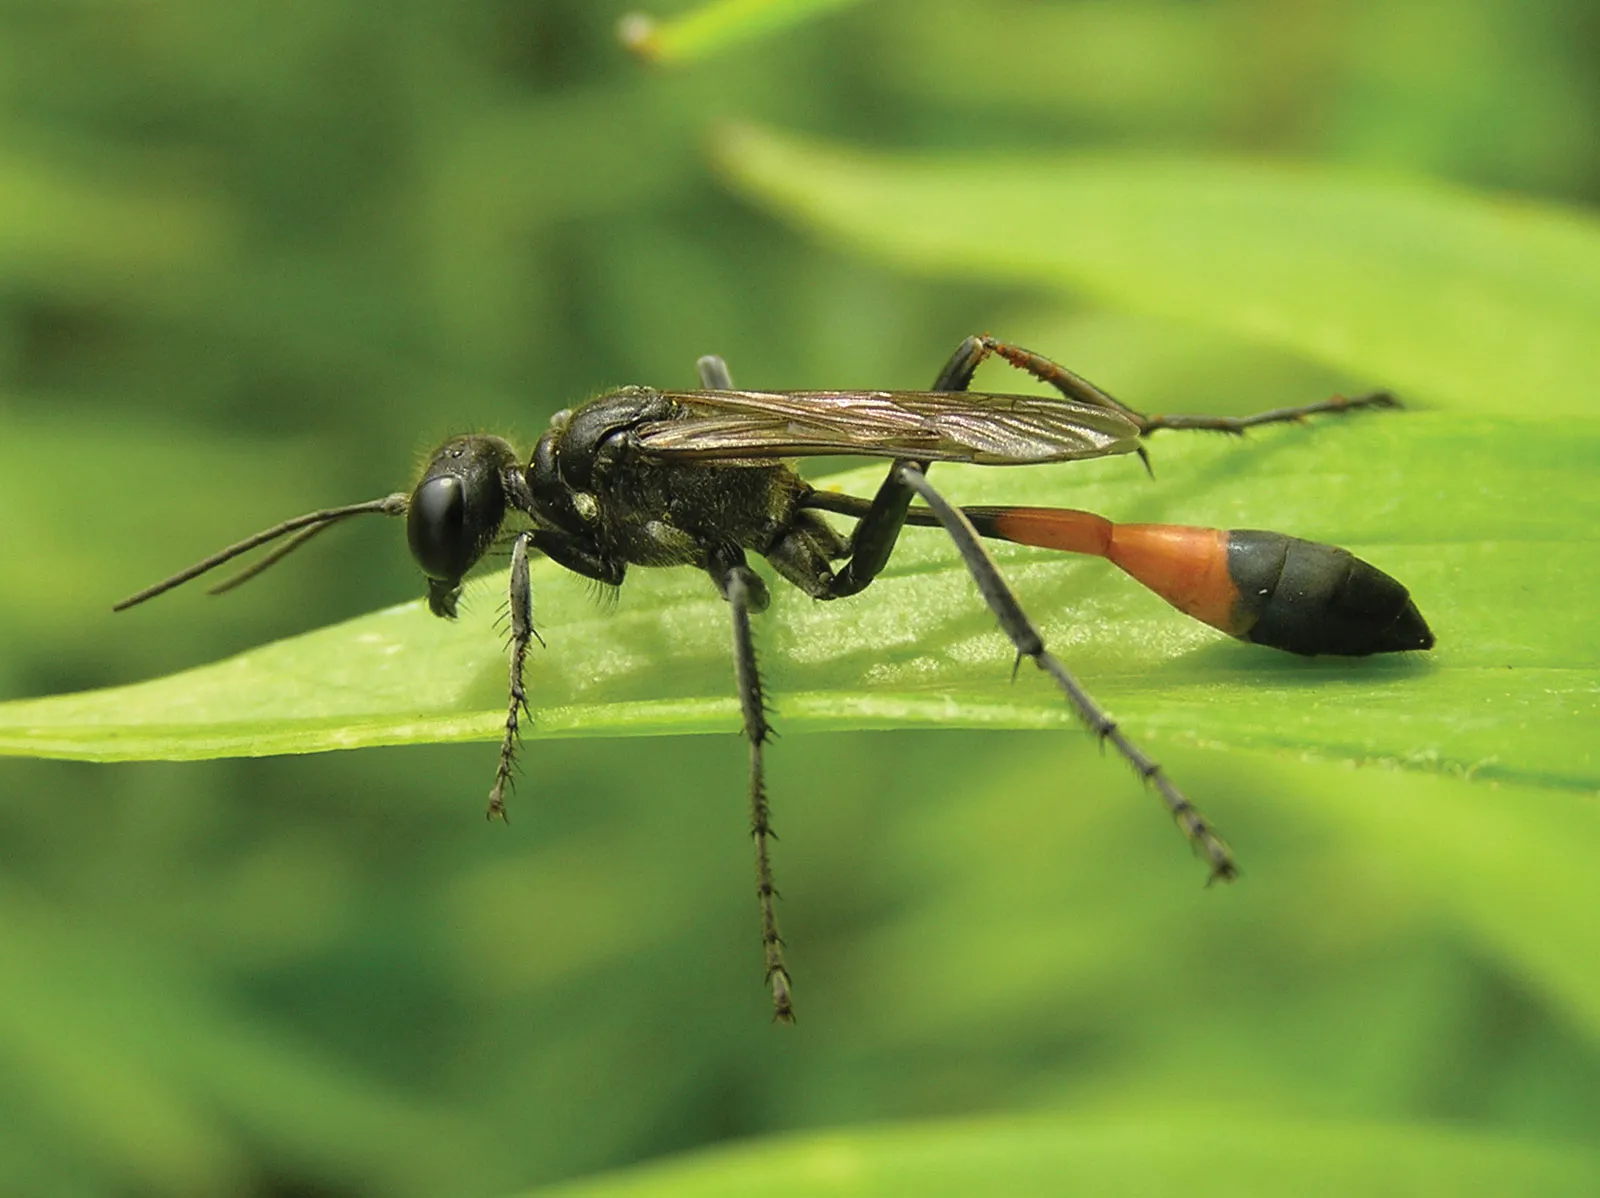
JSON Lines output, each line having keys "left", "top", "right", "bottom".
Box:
{"left": 896, "top": 464, "right": 1238, "bottom": 881}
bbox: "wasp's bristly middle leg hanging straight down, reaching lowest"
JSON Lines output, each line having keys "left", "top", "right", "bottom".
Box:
{"left": 709, "top": 547, "right": 795, "bottom": 1024}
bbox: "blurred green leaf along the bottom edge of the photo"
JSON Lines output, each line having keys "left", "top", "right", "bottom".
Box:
{"left": 542, "top": 1110, "right": 1600, "bottom": 1198}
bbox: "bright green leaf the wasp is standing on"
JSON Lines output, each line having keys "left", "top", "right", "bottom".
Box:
{"left": 0, "top": 413, "right": 1600, "bottom": 789}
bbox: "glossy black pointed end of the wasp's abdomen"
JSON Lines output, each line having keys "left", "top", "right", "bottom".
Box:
{"left": 1227, "top": 529, "right": 1434, "bottom": 657}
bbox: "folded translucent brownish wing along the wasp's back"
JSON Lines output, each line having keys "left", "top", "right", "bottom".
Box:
{"left": 634, "top": 390, "right": 1139, "bottom": 465}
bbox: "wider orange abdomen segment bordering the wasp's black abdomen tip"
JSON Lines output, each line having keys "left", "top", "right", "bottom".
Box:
{"left": 1106, "top": 525, "right": 1254, "bottom": 637}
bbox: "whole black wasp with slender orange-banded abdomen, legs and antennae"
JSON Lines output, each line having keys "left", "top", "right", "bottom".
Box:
{"left": 115, "top": 336, "right": 1434, "bottom": 1022}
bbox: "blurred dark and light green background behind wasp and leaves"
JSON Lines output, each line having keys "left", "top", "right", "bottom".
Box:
{"left": 0, "top": 0, "right": 1600, "bottom": 1198}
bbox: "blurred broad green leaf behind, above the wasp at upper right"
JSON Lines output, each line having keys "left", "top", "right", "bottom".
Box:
{"left": 718, "top": 128, "right": 1600, "bottom": 414}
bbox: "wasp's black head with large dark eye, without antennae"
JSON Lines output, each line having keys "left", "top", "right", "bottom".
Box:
{"left": 406, "top": 437, "right": 517, "bottom": 607}
